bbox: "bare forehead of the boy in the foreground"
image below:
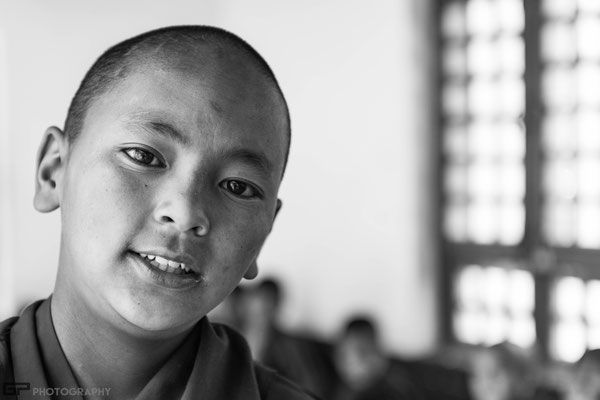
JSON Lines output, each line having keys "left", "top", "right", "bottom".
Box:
{"left": 83, "top": 56, "right": 289, "bottom": 174}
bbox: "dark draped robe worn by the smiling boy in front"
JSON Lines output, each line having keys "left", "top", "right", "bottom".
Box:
{"left": 0, "top": 299, "right": 313, "bottom": 400}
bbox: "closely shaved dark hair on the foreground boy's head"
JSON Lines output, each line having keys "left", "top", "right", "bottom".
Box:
{"left": 64, "top": 25, "right": 291, "bottom": 169}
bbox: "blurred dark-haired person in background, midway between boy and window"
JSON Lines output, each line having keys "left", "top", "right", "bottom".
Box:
{"left": 333, "top": 316, "right": 423, "bottom": 400}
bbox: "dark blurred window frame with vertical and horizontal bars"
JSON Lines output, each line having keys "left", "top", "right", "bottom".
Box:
{"left": 435, "top": 0, "right": 600, "bottom": 361}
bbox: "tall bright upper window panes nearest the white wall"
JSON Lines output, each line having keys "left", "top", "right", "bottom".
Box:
{"left": 442, "top": 0, "right": 525, "bottom": 245}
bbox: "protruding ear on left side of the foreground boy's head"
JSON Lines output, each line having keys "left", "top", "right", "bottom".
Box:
{"left": 33, "top": 126, "right": 68, "bottom": 212}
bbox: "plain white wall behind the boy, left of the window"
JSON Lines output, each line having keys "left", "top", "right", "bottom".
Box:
{"left": 0, "top": 0, "right": 437, "bottom": 354}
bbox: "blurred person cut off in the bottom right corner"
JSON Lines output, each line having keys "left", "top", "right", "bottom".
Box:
{"left": 564, "top": 349, "right": 600, "bottom": 400}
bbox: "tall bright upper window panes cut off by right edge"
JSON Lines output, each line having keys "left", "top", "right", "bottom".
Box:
{"left": 540, "top": 0, "right": 600, "bottom": 249}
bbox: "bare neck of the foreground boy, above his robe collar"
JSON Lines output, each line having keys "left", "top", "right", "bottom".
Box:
{"left": 51, "top": 291, "right": 191, "bottom": 399}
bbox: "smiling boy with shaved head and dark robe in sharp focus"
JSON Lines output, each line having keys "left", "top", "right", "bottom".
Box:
{"left": 0, "top": 26, "right": 310, "bottom": 400}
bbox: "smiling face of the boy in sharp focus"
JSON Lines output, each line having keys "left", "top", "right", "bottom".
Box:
{"left": 42, "top": 53, "right": 287, "bottom": 331}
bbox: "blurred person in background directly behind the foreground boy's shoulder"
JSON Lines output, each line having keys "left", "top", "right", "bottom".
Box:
{"left": 236, "top": 278, "right": 335, "bottom": 399}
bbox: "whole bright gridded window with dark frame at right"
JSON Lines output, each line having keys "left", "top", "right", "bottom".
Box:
{"left": 439, "top": 0, "right": 600, "bottom": 362}
